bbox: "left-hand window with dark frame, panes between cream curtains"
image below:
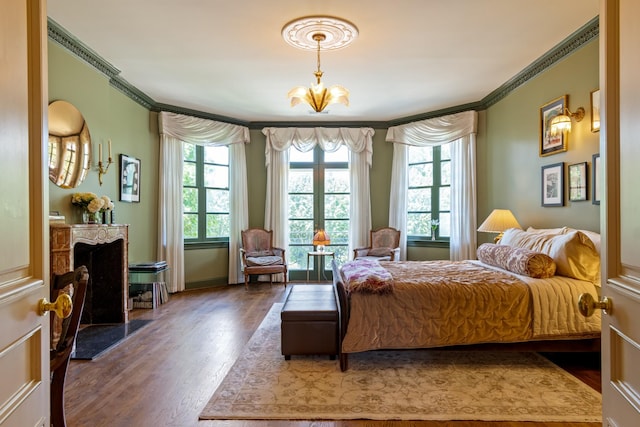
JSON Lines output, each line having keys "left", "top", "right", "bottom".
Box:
{"left": 182, "top": 144, "right": 229, "bottom": 243}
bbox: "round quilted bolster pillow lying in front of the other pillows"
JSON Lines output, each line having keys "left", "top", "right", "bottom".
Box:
{"left": 477, "top": 243, "right": 556, "bottom": 279}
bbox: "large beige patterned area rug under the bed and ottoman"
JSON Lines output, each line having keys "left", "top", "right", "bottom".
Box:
{"left": 200, "top": 304, "right": 602, "bottom": 422}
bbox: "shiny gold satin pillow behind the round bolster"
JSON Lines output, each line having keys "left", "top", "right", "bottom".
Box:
{"left": 500, "top": 229, "right": 600, "bottom": 283}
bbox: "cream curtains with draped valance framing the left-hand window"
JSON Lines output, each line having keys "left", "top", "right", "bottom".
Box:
{"left": 157, "top": 111, "right": 249, "bottom": 292}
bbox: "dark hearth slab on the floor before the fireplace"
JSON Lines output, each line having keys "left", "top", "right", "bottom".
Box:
{"left": 71, "top": 319, "right": 151, "bottom": 360}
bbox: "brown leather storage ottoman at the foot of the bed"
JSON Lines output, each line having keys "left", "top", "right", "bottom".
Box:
{"left": 280, "top": 284, "right": 339, "bottom": 360}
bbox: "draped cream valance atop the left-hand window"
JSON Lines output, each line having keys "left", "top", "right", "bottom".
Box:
{"left": 158, "top": 111, "right": 249, "bottom": 145}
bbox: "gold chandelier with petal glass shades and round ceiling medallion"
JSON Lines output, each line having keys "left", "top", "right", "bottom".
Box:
{"left": 282, "top": 16, "right": 358, "bottom": 113}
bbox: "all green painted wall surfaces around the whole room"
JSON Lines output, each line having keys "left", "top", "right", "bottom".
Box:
{"left": 49, "top": 35, "right": 599, "bottom": 288}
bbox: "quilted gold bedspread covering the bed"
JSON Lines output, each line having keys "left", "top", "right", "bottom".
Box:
{"left": 342, "top": 261, "right": 599, "bottom": 353}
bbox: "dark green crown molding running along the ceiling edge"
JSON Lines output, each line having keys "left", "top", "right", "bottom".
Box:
{"left": 47, "top": 16, "right": 600, "bottom": 129}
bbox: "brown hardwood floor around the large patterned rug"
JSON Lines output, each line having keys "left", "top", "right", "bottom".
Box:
{"left": 65, "top": 284, "right": 601, "bottom": 427}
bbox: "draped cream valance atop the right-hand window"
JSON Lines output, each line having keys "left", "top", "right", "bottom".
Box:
{"left": 386, "top": 111, "right": 478, "bottom": 146}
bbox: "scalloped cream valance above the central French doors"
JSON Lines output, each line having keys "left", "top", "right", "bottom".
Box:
{"left": 262, "top": 127, "right": 375, "bottom": 167}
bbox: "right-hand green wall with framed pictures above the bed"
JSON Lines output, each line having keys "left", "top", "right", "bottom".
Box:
{"left": 477, "top": 39, "right": 600, "bottom": 242}
